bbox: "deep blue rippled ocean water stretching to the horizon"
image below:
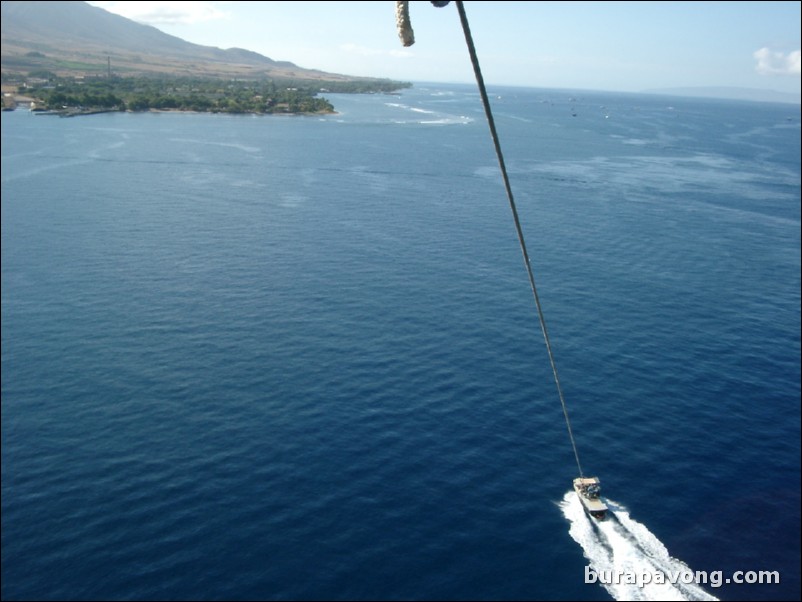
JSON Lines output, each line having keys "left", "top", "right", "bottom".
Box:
{"left": 2, "top": 84, "right": 801, "bottom": 600}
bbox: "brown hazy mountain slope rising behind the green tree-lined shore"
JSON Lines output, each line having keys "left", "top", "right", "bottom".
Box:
{"left": 0, "top": 0, "right": 365, "bottom": 81}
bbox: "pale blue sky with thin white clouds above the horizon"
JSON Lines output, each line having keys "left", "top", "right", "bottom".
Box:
{"left": 84, "top": 0, "right": 802, "bottom": 95}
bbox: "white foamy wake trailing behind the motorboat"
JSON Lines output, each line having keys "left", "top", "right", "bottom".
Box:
{"left": 560, "top": 491, "right": 718, "bottom": 600}
